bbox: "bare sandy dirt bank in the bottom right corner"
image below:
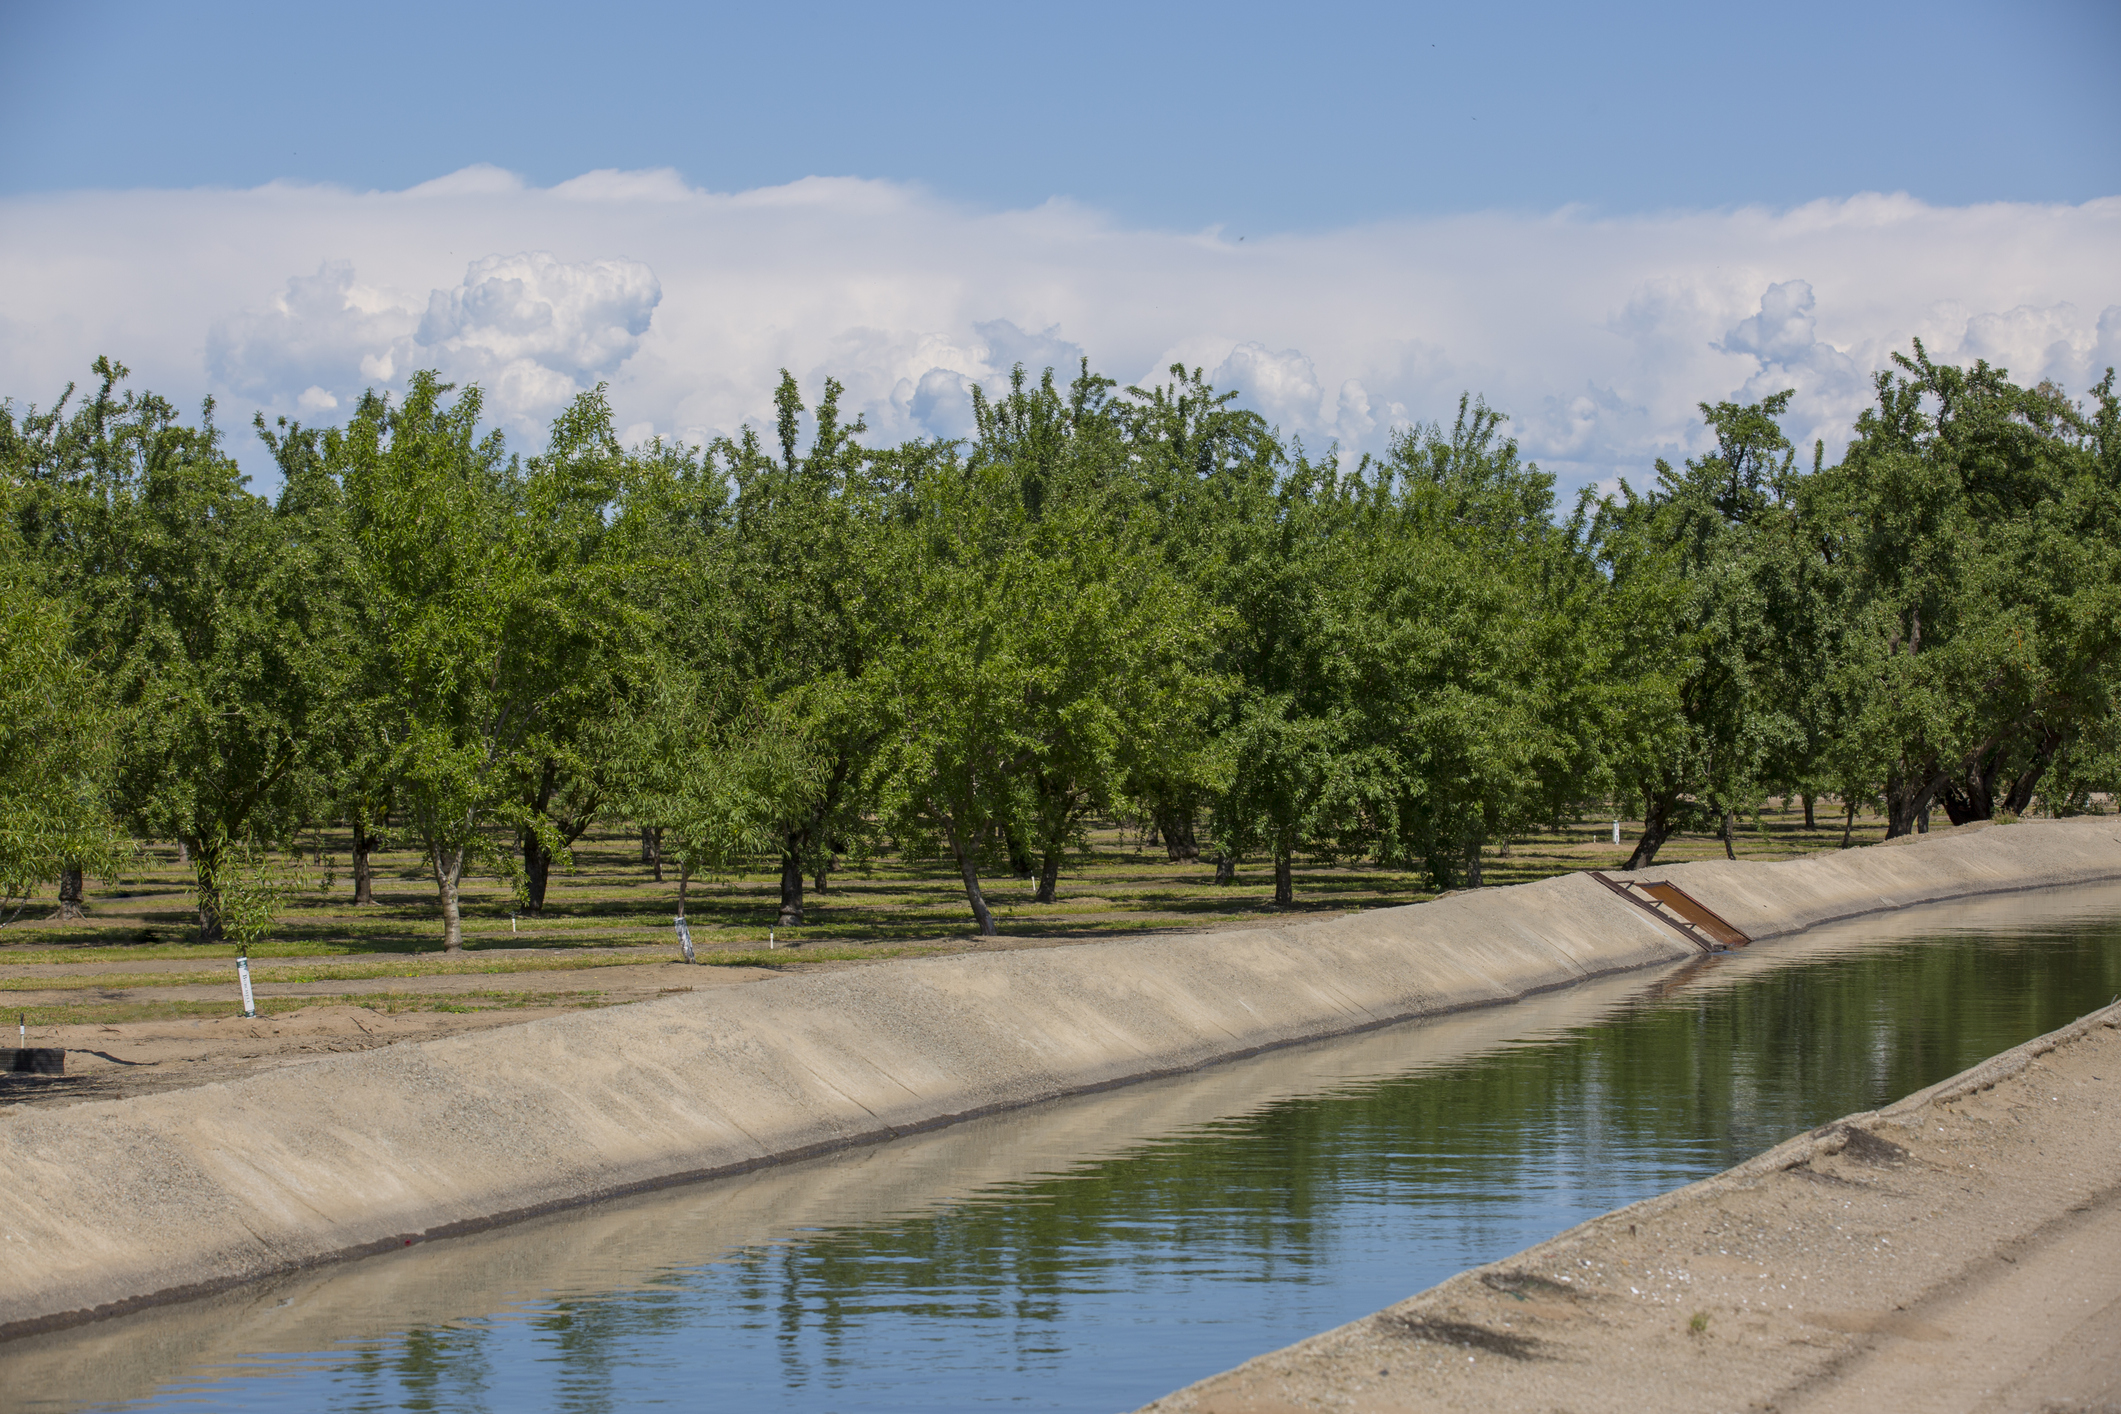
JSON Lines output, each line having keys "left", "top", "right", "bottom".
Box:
{"left": 1145, "top": 1007, "right": 2121, "bottom": 1414}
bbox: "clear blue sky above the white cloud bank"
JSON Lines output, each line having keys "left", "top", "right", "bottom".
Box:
{"left": 0, "top": 0, "right": 2121, "bottom": 231}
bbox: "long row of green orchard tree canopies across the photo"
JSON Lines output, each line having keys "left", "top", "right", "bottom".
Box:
{"left": 0, "top": 343, "right": 2121, "bottom": 948}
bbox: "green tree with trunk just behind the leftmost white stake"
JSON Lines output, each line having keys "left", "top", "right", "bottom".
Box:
{"left": 8, "top": 358, "right": 341, "bottom": 941}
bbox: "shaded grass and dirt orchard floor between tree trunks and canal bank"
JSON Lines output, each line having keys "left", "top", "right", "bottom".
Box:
{"left": 0, "top": 801, "right": 1886, "bottom": 1111}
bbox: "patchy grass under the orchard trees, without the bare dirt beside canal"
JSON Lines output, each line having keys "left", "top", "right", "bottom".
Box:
{"left": 0, "top": 808, "right": 1883, "bottom": 996}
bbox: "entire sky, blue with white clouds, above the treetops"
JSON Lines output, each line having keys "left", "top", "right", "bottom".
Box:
{"left": 0, "top": 0, "right": 2121, "bottom": 496}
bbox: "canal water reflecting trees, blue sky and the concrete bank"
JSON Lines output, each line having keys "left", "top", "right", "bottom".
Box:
{"left": 12, "top": 886, "right": 2121, "bottom": 1414}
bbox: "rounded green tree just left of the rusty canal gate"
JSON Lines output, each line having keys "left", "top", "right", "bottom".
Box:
{"left": 1349, "top": 396, "right": 1610, "bottom": 888}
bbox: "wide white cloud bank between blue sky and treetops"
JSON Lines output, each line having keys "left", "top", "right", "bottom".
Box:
{"left": 0, "top": 167, "right": 2121, "bottom": 496}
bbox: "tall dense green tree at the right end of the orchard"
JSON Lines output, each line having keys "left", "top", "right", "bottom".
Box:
{"left": 1822, "top": 351, "right": 2121, "bottom": 835}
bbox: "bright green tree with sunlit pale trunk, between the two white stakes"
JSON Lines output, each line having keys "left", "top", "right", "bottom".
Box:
{"left": 335, "top": 373, "right": 634, "bottom": 952}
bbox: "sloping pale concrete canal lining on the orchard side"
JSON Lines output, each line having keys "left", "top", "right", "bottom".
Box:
{"left": 0, "top": 818, "right": 2121, "bottom": 1336}
